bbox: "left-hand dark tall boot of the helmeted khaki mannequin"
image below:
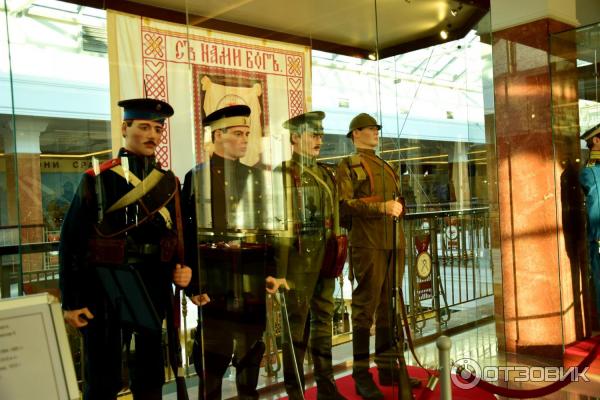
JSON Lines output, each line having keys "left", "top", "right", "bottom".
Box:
{"left": 352, "top": 328, "right": 383, "bottom": 400}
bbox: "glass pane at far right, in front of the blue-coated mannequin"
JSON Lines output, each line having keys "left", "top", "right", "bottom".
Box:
{"left": 550, "top": 20, "right": 600, "bottom": 335}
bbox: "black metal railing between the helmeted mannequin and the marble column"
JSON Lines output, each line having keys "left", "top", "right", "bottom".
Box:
{"left": 402, "top": 207, "right": 494, "bottom": 336}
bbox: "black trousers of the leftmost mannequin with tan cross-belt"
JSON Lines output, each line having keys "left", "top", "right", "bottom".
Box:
{"left": 81, "top": 262, "right": 171, "bottom": 400}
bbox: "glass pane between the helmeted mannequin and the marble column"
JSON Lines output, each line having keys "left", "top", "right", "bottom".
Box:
{"left": 373, "top": 7, "right": 499, "bottom": 392}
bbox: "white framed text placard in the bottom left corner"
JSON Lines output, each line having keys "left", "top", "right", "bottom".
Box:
{"left": 0, "top": 293, "right": 79, "bottom": 400}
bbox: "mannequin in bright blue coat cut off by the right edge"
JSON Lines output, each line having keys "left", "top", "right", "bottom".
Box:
{"left": 579, "top": 124, "right": 600, "bottom": 315}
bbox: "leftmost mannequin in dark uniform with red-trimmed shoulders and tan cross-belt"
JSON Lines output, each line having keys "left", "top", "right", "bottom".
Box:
{"left": 59, "top": 99, "right": 191, "bottom": 400}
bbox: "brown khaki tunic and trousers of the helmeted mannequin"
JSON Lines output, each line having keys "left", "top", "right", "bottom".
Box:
{"left": 337, "top": 149, "right": 405, "bottom": 330}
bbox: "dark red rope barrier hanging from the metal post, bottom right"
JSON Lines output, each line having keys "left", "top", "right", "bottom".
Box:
{"left": 454, "top": 343, "right": 600, "bottom": 400}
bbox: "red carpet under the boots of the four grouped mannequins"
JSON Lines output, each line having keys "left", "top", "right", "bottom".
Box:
{"left": 288, "top": 366, "right": 496, "bottom": 400}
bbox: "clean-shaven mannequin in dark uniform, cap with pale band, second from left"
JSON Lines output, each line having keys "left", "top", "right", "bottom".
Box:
{"left": 182, "top": 105, "right": 273, "bottom": 399}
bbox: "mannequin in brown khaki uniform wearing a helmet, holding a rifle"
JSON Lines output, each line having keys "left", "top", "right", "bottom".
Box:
{"left": 337, "top": 113, "right": 418, "bottom": 399}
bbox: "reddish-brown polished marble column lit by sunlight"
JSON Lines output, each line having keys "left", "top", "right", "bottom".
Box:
{"left": 492, "top": 0, "right": 587, "bottom": 360}
